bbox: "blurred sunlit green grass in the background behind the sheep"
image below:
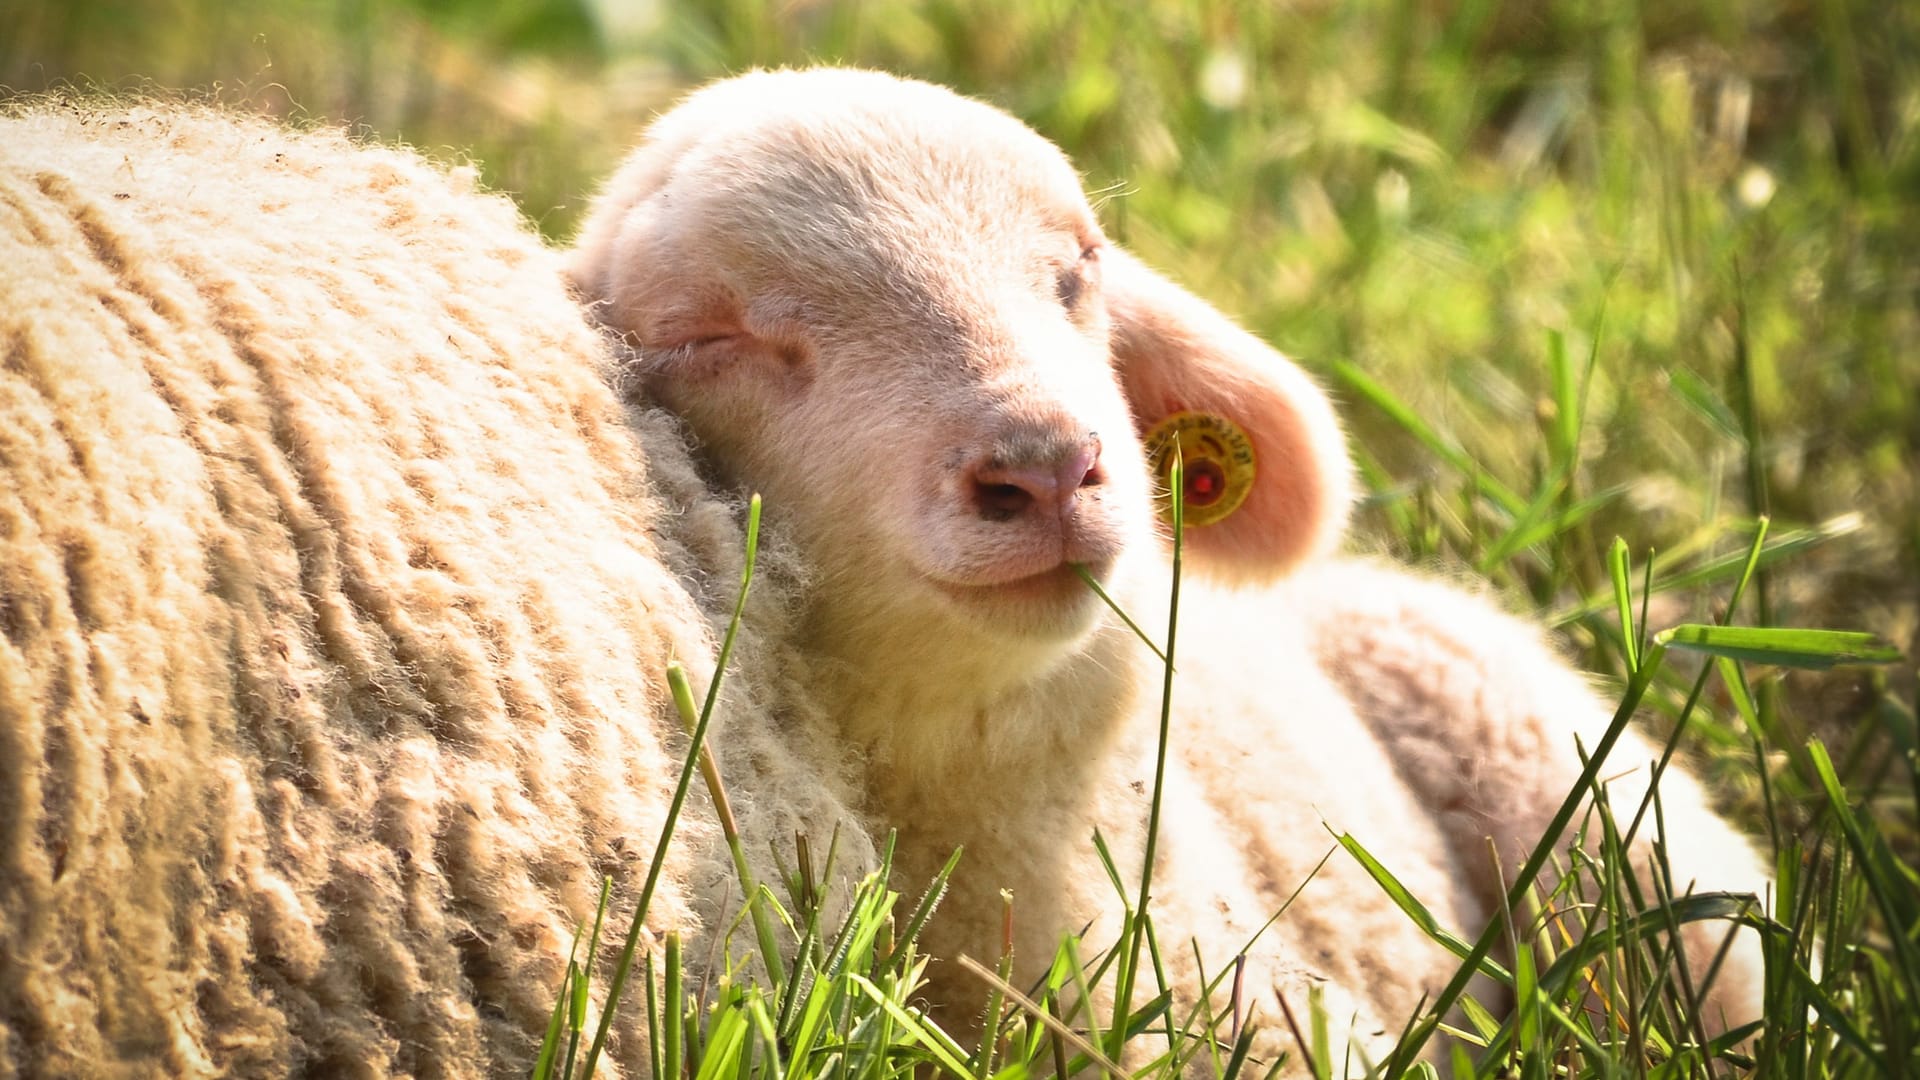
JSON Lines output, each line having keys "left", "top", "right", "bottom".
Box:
{"left": 0, "top": 0, "right": 1920, "bottom": 730}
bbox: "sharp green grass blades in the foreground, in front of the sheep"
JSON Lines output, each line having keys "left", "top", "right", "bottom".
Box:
{"left": 534, "top": 470, "right": 1920, "bottom": 1080}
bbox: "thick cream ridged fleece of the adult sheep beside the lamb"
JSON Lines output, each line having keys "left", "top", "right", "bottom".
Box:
{"left": 0, "top": 100, "right": 871, "bottom": 1076}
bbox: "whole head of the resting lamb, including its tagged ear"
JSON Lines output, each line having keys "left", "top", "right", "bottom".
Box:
{"left": 572, "top": 69, "right": 1348, "bottom": 672}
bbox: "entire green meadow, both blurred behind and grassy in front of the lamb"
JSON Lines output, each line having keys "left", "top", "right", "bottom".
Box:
{"left": 0, "top": 0, "right": 1920, "bottom": 1080}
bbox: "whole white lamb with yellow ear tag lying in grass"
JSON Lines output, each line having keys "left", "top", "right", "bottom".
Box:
{"left": 568, "top": 69, "right": 1766, "bottom": 1068}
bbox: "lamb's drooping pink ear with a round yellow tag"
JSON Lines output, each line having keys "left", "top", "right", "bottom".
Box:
{"left": 1102, "top": 248, "right": 1354, "bottom": 580}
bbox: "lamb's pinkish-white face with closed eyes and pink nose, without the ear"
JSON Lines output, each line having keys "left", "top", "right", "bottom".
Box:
{"left": 572, "top": 71, "right": 1152, "bottom": 653}
